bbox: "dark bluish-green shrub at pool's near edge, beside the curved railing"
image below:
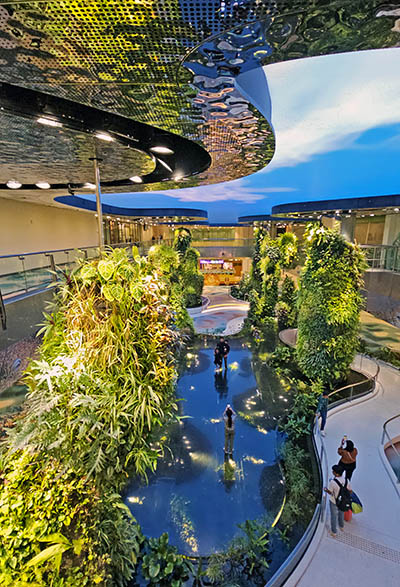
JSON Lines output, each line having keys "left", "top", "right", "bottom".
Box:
{"left": 207, "top": 519, "right": 269, "bottom": 587}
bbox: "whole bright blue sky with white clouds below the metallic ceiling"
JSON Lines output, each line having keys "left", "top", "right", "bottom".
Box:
{"left": 80, "top": 48, "right": 400, "bottom": 222}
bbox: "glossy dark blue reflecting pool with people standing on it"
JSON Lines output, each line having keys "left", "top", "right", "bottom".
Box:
{"left": 124, "top": 338, "right": 286, "bottom": 555}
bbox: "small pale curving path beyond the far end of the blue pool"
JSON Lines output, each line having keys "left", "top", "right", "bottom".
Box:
{"left": 193, "top": 286, "right": 249, "bottom": 336}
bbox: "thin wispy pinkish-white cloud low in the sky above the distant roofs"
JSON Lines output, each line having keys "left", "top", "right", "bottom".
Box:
{"left": 157, "top": 184, "right": 295, "bottom": 203}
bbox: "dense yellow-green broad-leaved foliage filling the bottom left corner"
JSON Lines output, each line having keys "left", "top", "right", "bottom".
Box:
{"left": 0, "top": 450, "right": 109, "bottom": 587}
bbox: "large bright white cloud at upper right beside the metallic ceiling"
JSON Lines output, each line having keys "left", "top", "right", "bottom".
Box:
{"left": 264, "top": 48, "right": 400, "bottom": 171}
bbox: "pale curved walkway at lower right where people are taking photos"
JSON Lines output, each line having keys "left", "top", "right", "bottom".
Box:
{"left": 285, "top": 355, "right": 400, "bottom": 587}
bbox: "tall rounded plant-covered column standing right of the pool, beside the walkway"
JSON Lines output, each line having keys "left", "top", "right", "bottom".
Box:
{"left": 297, "top": 225, "right": 365, "bottom": 387}
